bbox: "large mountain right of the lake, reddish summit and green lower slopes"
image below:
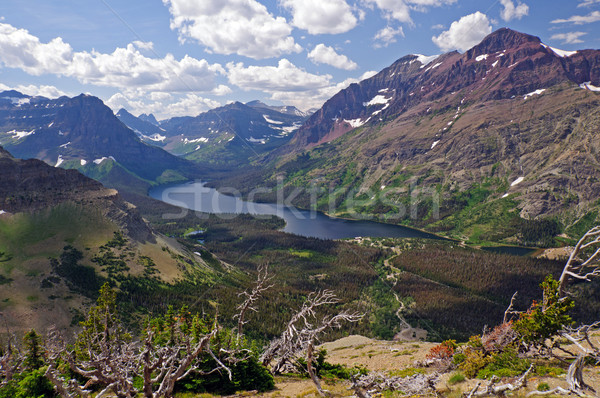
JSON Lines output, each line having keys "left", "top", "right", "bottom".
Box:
{"left": 215, "top": 29, "right": 600, "bottom": 241}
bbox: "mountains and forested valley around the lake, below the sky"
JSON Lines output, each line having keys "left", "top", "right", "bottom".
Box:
{"left": 0, "top": 29, "right": 600, "bottom": 391}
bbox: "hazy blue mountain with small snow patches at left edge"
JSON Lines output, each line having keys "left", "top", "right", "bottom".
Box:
{"left": 0, "top": 92, "right": 195, "bottom": 194}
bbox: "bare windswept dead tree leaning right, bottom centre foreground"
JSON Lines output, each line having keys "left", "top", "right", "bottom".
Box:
{"left": 260, "top": 290, "right": 364, "bottom": 395}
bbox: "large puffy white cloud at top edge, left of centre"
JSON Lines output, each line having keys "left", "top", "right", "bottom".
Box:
{"left": 163, "top": 0, "right": 302, "bottom": 59}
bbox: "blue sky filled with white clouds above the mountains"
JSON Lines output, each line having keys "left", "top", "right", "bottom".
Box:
{"left": 0, "top": 0, "right": 600, "bottom": 119}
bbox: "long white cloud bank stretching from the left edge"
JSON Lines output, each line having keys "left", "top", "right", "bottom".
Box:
{"left": 0, "top": 23, "right": 225, "bottom": 92}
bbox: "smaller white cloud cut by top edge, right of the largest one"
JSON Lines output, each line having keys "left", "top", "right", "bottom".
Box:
{"left": 279, "top": 0, "right": 364, "bottom": 35}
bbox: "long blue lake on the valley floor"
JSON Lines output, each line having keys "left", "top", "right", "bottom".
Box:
{"left": 149, "top": 182, "right": 443, "bottom": 239}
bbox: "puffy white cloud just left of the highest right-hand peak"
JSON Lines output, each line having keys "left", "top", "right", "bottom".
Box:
{"left": 431, "top": 11, "right": 492, "bottom": 51}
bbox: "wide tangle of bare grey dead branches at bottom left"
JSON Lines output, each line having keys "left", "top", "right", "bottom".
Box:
{"left": 46, "top": 325, "right": 231, "bottom": 398}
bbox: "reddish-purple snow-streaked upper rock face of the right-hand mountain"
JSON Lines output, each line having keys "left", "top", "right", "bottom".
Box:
{"left": 288, "top": 29, "right": 600, "bottom": 149}
